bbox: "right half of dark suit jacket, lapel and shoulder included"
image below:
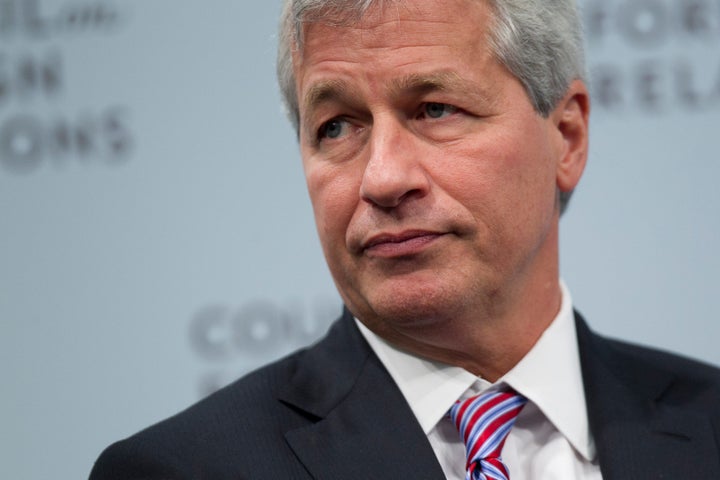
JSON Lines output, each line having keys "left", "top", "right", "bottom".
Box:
{"left": 576, "top": 315, "right": 720, "bottom": 480}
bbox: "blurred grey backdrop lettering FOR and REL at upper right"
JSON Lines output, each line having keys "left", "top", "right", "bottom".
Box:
{"left": 582, "top": 0, "right": 720, "bottom": 114}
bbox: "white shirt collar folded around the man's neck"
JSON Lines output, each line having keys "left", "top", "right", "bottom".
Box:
{"left": 355, "top": 282, "right": 595, "bottom": 460}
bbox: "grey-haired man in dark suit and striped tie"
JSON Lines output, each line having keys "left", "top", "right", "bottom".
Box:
{"left": 91, "top": 0, "right": 720, "bottom": 480}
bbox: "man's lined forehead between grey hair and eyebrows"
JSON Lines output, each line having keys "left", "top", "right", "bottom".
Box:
{"left": 293, "top": 0, "right": 491, "bottom": 98}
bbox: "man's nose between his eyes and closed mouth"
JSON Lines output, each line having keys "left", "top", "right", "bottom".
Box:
{"left": 360, "top": 119, "right": 430, "bottom": 209}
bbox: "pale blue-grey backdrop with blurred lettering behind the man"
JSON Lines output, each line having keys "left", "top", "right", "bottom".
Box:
{"left": 0, "top": 0, "right": 720, "bottom": 480}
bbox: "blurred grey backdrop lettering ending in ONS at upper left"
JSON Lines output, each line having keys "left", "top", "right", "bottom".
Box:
{"left": 0, "top": 0, "right": 133, "bottom": 174}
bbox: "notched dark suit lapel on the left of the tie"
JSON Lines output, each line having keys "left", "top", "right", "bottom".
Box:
{"left": 280, "top": 311, "right": 444, "bottom": 480}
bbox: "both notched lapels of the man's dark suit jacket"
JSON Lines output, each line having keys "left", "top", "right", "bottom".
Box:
{"left": 280, "top": 310, "right": 720, "bottom": 480}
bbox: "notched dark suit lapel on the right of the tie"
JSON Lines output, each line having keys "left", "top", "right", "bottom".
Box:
{"left": 576, "top": 314, "right": 720, "bottom": 480}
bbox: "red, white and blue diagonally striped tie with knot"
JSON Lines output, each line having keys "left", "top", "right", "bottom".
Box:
{"left": 450, "top": 391, "right": 527, "bottom": 480}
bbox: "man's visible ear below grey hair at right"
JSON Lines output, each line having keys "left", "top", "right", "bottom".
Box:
{"left": 550, "top": 80, "right": 590, "bottom": 192}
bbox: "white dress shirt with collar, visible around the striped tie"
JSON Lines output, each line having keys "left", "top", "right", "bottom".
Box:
{"left": 356, "top": 282, "right": 602, "bottom": 480}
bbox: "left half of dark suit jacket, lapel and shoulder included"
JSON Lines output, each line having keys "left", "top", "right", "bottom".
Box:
{"left": 90, "top": 312, "right": 443, "bottom": 480}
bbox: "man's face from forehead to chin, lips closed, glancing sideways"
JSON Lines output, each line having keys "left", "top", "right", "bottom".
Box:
{"left": 294, "top": 0, "right": 592, "bottom": 344}
